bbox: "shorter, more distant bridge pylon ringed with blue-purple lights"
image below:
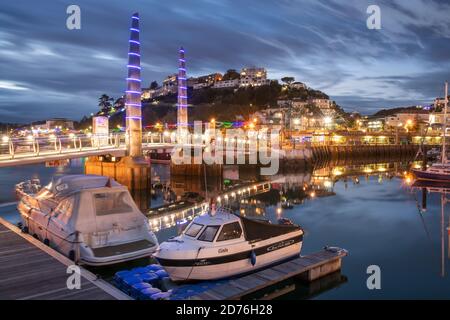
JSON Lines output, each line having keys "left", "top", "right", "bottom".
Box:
{"left": 177, "top": 47, "right": 189, "bottom": 141}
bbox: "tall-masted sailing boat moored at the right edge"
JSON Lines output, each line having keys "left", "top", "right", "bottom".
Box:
{"left": 412, "top": 82, "right": 450, "bottom": 182}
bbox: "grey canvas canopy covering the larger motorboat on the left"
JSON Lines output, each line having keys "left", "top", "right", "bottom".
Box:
{"left": 32, "top": 175, "right": 147, "bottom": 233}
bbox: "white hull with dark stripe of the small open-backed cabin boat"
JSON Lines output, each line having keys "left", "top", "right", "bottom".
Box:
{"left": 155, "top": 236, "right": 303, "bottom": 282}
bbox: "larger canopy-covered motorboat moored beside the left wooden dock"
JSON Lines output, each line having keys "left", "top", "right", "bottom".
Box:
{"left": 16, "top": 175, "right": 158, "bottom": 266}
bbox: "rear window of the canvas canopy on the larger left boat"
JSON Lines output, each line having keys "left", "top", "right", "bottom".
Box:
{"left": 94, "top": 191, "right": 133, "bottom": 216}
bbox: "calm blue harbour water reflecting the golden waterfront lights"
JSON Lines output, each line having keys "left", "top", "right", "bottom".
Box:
{"left": 0, "top": 160, "right": 450, "bottom": 299}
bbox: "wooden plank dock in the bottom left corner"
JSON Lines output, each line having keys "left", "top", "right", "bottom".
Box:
{"left": 0, "top": 218, "right": 129, "bottom": 300}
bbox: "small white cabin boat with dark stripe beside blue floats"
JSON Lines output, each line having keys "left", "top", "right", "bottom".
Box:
{"left": 154, "top": 208, "right": 303, "bottom": 281}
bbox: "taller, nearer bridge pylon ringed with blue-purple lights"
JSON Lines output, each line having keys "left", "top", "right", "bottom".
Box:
{"left": 125, "top": 13, "right": 142, "bottom": 157}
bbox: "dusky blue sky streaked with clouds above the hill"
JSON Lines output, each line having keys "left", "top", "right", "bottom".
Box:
{"left": 0, "top": 0, "right": 450, "bottom": 122}
